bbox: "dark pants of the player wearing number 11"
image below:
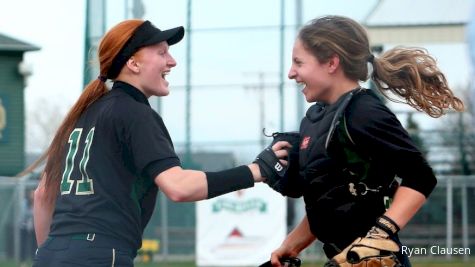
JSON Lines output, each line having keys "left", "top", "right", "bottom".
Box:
{"left": 33, "top": 234, "right": 135, "bottom": 267}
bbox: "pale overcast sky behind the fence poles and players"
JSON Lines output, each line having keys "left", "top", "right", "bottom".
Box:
{"left": 0, "top": 0, "right": 469, "bottom": 156}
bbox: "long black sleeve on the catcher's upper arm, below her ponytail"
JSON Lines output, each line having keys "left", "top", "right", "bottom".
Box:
{"left": 346, "top": 94, "right": 437, "bottom": 197}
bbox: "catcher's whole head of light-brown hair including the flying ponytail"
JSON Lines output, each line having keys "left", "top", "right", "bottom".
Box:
{"left": 298, "top": 16, "right": 464, "bottom": 117}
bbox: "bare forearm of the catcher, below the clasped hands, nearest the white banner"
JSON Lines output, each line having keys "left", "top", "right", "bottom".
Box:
{"left": 282, "top": 215, "right": 317, "bottom": 255}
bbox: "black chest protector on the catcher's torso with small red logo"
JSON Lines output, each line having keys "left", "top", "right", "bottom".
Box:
{"left": 300, "top": 88, "right": 395, "bottom": 244}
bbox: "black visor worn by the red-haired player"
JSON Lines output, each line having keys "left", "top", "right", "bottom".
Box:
{"left": 107, "top": 20, "right": 185, "bottom": 79}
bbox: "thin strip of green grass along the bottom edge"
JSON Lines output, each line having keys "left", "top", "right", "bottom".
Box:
{"left": 0, "top": 257, "right": 475, "bottom": 267}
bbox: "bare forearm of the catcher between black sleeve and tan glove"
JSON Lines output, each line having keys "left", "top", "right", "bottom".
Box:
{"left": 385, "top": 186, "right": 426, "bottom": 229}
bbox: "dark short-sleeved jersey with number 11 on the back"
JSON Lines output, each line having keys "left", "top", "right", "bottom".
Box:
{"left": 50, "top": 81, "right": 180, "bottom": 249}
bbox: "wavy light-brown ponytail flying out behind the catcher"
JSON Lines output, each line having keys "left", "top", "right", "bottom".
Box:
{"left": 371, "top": 47, "right": 464, "bottom": 118}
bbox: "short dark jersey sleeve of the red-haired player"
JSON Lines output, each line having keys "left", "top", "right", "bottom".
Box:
{"left": 127, "top": 108, "right": 180, "bottom": 179}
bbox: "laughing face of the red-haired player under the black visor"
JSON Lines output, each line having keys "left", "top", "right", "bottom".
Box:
{"left": 133, "top": 41, "right": 176, "bottom": 97}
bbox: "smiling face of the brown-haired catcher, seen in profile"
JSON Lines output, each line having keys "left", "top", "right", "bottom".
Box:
{"left": 288, "top": 39, "right": 333, "bottom": 103}
